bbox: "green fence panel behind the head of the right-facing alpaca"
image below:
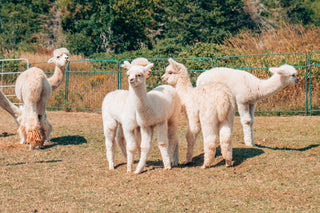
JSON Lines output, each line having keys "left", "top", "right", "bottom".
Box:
{"left": 215, "top": 53, "right": 309, "bottom": 115}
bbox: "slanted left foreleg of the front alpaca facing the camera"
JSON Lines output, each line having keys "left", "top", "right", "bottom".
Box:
{"left": 134, "top": 127, "right": 154, "bottom": 174}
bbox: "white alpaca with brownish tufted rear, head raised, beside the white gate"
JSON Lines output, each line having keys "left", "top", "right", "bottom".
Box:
{"left": 15, "top": 48, "right": 69, "bottom": 149}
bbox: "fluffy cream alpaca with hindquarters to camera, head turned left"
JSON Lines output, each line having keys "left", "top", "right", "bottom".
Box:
{"left": 162, "top": 58, "right": 235, "bottom": 168}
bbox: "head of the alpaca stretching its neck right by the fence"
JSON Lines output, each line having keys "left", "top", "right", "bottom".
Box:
{"left": 269, "top": 64, "right": 299, "bottom": 85}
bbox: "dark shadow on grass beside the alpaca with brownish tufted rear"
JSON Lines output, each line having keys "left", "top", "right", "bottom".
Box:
{"left": 42, "top": 135, "right": 87, "bottom": 149}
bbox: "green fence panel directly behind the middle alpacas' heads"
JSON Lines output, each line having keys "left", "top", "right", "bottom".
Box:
{"left": 120, "top": 57, "right": 213, "bottom": 90}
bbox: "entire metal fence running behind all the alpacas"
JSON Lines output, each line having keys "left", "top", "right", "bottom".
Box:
{"left": 0, "top": 51, "right": 320, "bottom": 115}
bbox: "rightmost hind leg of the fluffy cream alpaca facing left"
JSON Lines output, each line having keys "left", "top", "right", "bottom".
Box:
{"left": 219, "top": 121, "right": 233, "bottom": 166}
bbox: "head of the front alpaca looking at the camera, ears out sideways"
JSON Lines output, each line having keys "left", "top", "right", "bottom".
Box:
{"left": 122, "top": 61, "right": 153, "bottom": 87}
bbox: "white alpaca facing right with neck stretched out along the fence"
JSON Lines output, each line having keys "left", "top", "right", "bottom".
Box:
{"left": 197, "top": 64, "right": 298, "bottom": 146}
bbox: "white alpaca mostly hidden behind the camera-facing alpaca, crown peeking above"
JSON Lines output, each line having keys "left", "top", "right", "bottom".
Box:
{"left": 102, "top": 58, "right": 149, "bottom": 172}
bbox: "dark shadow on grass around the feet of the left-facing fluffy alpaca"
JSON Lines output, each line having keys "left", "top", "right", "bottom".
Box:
{"left": 182, "top": 147, "right": 264, "bottom": 167}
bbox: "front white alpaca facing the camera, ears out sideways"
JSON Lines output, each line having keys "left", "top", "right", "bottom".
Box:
{"left": 123, "top": 61, "right": 181, "bottom": 174}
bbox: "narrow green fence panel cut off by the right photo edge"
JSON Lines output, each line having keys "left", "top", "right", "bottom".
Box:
{"left": 308, "top": 51, "right": 320, "bottom": 115}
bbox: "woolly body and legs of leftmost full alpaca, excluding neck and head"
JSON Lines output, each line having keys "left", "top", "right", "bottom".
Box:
{"left": 15, "top": 67, "right": 52, "bottom": 148}
